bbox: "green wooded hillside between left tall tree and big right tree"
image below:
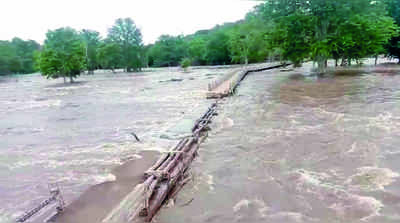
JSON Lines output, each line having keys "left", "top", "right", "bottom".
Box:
{"left": 148, "top": 20, "right": 269, "bottom": 67}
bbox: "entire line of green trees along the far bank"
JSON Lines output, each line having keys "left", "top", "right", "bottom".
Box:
{"left": 0, "top": 0, "right": 400, "bottom": 81}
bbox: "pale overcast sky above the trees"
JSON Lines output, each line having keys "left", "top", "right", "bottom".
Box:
{"left": 0, "top": 0, "right": 257, "bottom": 43}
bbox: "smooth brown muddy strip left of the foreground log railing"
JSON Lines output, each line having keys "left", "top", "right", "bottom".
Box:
{"left": 56, "top": 151, "right": 160, "bottom": 223}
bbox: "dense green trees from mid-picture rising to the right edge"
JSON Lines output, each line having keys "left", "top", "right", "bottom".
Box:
{"left": 146, "top": 0, "right": 400, "bottom": 69}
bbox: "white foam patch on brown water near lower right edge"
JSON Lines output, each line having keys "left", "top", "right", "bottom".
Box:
{"left": 346, "top": 166, "right": 400, "bottom": 190}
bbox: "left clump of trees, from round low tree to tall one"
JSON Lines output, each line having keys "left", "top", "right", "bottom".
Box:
{"left": 36, "top": 18, "right": 146, "bottom": 82}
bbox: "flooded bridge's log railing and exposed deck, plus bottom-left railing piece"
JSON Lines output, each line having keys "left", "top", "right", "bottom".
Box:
{"left": 16, "top": 63, "right": 289, "bottom": 223}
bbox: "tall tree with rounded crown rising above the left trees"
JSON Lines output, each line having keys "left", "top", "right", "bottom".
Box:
{"left": 107, "top": 18, "right": 144, "bottom": 72}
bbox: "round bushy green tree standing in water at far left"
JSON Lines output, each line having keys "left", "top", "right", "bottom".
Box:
{"left": 37, "top": 27, "right": 86, "bottom": 83}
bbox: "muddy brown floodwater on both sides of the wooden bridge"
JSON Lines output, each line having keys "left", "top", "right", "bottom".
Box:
{"left": 0, "top": 62, "right": 400, "bottom": 223}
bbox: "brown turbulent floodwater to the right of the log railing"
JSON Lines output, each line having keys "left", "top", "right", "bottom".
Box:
{"left": 156, "top": 63, "right": 400, "bottom": 223}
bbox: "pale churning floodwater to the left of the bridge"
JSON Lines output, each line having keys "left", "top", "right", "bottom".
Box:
{"left": 0, "top": 68, "right": 234, "bottom": 223}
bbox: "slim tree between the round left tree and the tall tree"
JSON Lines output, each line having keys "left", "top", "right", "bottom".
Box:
{"left": 80, "top": 29, "right": 101, "bottom": 74}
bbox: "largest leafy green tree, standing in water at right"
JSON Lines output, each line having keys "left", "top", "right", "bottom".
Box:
{"left": 257, "top": 0, "right": 395, "bottom": 73}
